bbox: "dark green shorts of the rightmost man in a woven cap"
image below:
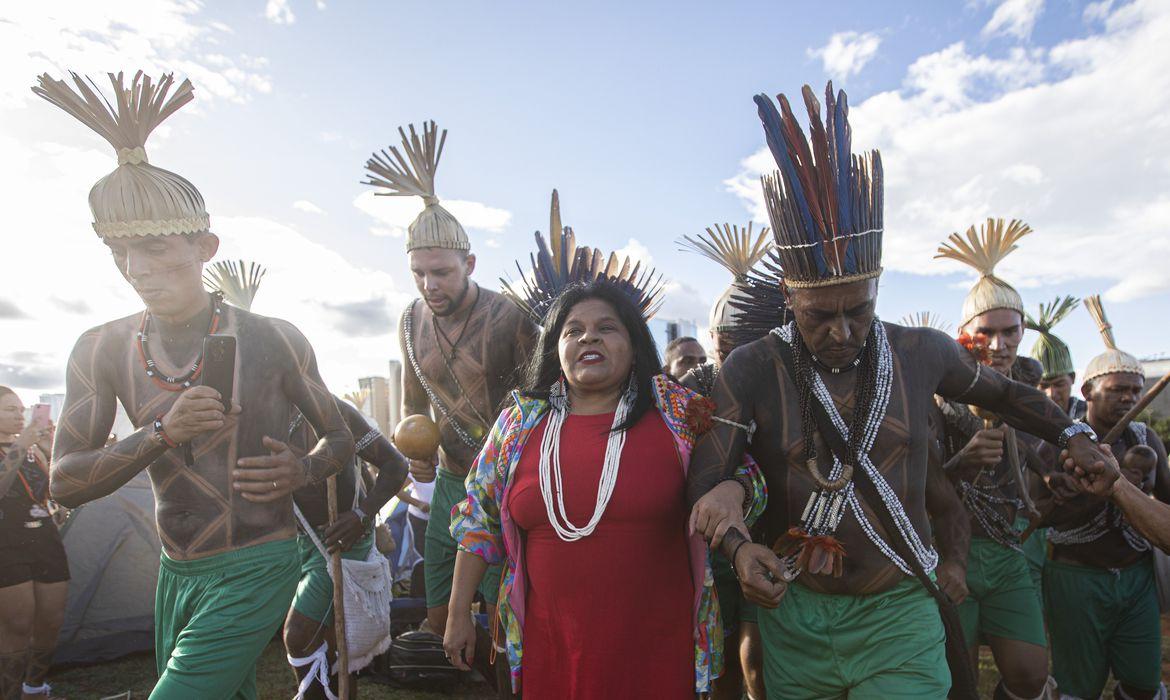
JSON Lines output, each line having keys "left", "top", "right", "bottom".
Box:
{"left": 1044, "top": 557, "right": 1162, "bottom": 698}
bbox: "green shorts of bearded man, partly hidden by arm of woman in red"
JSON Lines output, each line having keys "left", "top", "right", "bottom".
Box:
{"left": 422, "top": 468, "right": 501, "bottom": 608}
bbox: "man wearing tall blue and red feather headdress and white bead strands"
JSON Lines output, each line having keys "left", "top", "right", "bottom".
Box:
{"left": 688, "top": 85, "right": 1107, "bottom": 698}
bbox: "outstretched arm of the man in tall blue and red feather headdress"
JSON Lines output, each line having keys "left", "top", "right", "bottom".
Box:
{"left": 920, "top": 329, "right": 1072, "bottom": 444}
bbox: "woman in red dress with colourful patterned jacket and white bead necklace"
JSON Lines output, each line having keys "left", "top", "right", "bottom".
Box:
{"left": 445, "top": 261, "right": 763, "bottom": 699}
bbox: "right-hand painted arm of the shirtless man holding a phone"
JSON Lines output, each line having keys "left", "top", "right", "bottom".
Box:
{"left": 275, "top": 322, "right": 353, "bottom": 483}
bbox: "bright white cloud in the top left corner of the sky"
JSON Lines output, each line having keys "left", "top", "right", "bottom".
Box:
{"left": 0, "top": 0, "right": 271, "bottom": 109}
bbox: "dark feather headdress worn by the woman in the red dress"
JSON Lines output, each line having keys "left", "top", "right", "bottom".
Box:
{"left": 500, "top": 190, "right": 663, "bottom": 325}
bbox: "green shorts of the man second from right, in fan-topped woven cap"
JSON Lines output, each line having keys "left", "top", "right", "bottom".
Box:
{"left": 958, "top": 537, "right": 1048, "bottom": 647}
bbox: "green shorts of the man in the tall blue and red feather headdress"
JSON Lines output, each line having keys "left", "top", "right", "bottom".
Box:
{"left": 759, "top": 578, "right": 950, "bottom": 700}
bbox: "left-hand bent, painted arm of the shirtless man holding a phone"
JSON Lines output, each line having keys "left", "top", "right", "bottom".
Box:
{"left": 49, "top": 329, "right": 167, "bottom": 508}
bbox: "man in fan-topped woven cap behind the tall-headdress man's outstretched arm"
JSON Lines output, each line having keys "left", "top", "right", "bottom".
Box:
{"left": 936, "top": 219, "right": 1067, "bottom": 699}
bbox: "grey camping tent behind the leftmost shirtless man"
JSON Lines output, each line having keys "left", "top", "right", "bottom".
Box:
{"left": 54, "top": 472, "right": 160, "bottom": 664}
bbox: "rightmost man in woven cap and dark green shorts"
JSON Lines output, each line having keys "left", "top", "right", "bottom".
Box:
{"left": 1042, "top": 295, "right": 1170, "bottom": 700}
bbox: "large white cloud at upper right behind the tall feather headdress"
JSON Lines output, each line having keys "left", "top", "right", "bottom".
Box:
{"left": 725, "top": 0, "right": 1170, "bottom": 301}
